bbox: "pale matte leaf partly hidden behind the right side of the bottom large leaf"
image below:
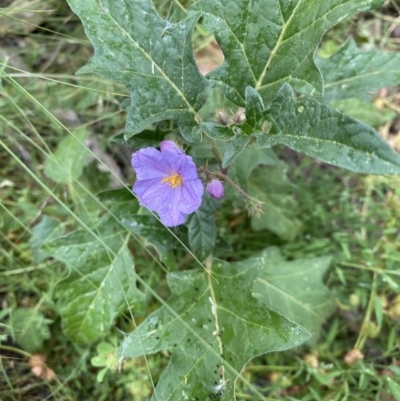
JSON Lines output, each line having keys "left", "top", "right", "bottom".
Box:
{"left": 253, "top": 248, "right": 335, "bottom": 341}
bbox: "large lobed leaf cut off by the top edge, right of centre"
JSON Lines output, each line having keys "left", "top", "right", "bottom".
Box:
{"left": 190, "top": 0, "right": 383, "bottom": 105}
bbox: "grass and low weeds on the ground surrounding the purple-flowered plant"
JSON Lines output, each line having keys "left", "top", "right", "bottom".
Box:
{"left": 0, "top": 0, "right": 400, "bottom": 401}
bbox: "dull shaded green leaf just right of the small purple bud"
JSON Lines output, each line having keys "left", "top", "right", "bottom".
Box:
{"left": 248, "top": 163, "right": 301, "bottom": 241}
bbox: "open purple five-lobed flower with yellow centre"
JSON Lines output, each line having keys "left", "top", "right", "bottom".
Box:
{"left": 132, "top": 141, "right": 204, "bottom": 227}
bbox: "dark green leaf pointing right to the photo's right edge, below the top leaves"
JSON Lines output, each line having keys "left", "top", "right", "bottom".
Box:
{"left": 256, "top": 84, "right": 400, "bottom": 174}
